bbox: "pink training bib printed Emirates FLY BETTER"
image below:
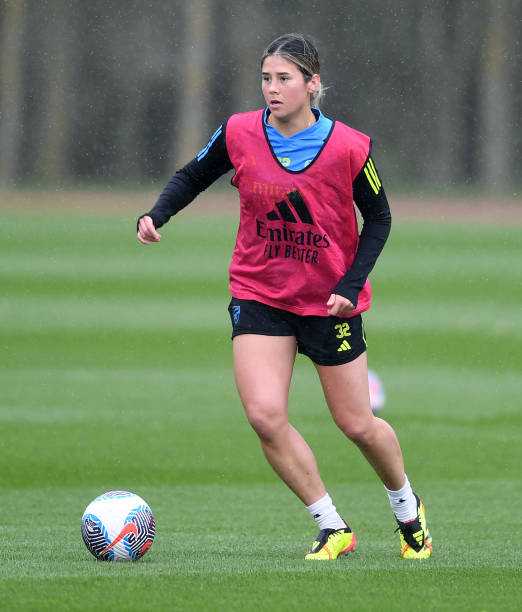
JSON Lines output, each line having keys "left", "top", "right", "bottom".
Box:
{"left": 226, "top": 110, "right": 371, "bottom": 316}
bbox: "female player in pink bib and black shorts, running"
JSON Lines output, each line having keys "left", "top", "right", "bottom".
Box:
{"left": 138, "top": 34, "right": 432, "bottom": 560}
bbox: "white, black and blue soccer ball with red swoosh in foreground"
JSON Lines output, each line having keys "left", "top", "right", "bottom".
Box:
{"left": 82, "top": 491, "right": 156, "bottom": 561}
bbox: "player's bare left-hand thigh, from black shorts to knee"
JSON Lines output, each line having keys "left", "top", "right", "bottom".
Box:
{"left": 233, "top": 334, "right": 296, "bottom": 418}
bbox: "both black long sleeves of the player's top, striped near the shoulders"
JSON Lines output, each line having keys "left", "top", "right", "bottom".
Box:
{"left": 142, "top": 124, "right": 391, "bottom": 306}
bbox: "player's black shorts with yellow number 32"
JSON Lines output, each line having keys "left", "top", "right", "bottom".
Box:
{"left": 228, "top": 298, "right": 366, "bottom": 365}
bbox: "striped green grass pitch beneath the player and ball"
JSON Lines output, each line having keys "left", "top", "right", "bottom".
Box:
{"left": 0, "top": 198, "right": 522, "bottom": 612}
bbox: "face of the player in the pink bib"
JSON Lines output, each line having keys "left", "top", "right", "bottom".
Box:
{"left": 261, "top": 55, "right": 319, "bottom": 122}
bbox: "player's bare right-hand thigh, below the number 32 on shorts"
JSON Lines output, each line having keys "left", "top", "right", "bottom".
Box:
{"left": 315, "top": 352, "right": 373, "bottom": 430}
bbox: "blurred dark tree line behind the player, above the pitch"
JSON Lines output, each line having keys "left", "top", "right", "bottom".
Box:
{"left": 0, "top": 0, "right": 522, "bottom": 194}
